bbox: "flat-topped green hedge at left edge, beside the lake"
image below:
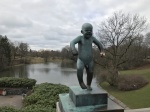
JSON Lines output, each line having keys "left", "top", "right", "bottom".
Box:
{"left": 0, "top": 77, "right": 36, "bottom": 88}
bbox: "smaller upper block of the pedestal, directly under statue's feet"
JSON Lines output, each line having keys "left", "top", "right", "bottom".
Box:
{"left": 69, "top": 86, "right": 108, "bottom": 107}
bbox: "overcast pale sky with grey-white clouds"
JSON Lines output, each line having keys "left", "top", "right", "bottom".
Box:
{"left": 0, "top": 0, "right": 150, "bottom": 50}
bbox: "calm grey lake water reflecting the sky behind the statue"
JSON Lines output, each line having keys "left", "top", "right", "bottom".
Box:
{"left": 0, "top": 62, "right": 97, "bottom": 86}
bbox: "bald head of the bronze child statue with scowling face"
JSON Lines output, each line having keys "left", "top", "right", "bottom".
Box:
{"left": 81, "top": 23, "right": 93, "bottom": 39}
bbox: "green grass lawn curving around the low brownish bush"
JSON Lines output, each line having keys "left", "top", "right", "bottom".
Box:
{"left": 101, "top": 67, "right": 150, "bottom": 109}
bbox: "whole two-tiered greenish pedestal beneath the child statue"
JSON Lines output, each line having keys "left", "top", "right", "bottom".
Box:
{"left": 59, "top": 86, "right": 124, "bottom": 112}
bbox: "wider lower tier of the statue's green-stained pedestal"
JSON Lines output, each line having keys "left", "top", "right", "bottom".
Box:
{"left": 59, "top": 94, "right": 124, "bottom": 112}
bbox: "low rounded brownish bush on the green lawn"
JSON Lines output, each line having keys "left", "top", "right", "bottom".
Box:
{"left": 118, "top": 75, "right": 148, "bottom": 91}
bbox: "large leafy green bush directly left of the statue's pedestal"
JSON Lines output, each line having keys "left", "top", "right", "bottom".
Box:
{"left": 23, "top": 83, "right": 69, "bottom": 112}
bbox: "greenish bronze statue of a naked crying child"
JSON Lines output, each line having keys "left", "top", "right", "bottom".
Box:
{"left": 70, "top": 23, "right": 105, "bottom": 90}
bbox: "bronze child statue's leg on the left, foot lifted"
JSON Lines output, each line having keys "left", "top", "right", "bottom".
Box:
{"left": 77, "top": 58, "right": 87, "bottom": 89}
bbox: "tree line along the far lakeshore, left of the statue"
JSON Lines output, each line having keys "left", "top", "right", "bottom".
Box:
{"left": 0, "top": 35, "right": 73, "bottom": 71}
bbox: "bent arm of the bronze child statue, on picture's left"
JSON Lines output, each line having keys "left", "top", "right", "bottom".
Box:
{"left": 70, "top": 36, "right": 81, "bottom": 55}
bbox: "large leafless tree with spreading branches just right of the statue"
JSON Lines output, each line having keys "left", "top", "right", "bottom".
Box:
{"left": 97, "top": 12, "right": 146, "bottom": 86}
